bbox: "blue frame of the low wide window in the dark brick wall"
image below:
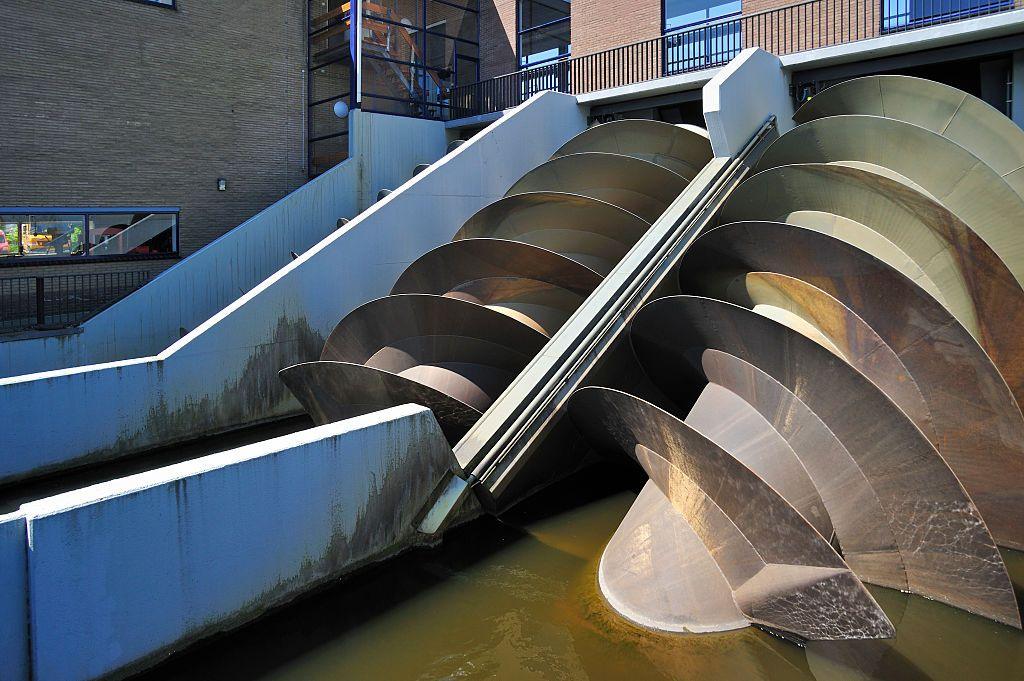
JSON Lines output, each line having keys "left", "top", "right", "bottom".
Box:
{"left": 0, "top": 206, "right": 181, "bottom": 268}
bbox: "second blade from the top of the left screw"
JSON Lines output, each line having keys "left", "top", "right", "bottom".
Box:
{"left": 506, "top": 152, "right": 687, "bottom": 222}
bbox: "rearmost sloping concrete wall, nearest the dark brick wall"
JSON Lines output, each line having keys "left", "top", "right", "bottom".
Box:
{"left": 0, "top": 112, "right": 445, "bottom": 377}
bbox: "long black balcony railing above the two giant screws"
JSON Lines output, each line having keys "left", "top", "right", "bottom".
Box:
{"left": 451, "top": 0, "right": 1015, "bottom": 118}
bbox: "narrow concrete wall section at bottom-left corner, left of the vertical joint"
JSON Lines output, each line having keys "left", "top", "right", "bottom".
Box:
{"left": 0, "top": 513, "right": 30, "bottom": 681}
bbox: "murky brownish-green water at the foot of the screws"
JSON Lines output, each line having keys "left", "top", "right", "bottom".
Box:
{"left": 147, "top": 471, "right": 1024, "bottom": 681}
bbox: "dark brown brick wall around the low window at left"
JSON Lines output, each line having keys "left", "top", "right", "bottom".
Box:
{"left": 0, "top": 0, "right": 305, "bottom": 276}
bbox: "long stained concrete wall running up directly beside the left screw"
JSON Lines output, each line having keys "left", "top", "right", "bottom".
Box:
{"left": 0, "top": 92, "right": 586, "bottom": 482}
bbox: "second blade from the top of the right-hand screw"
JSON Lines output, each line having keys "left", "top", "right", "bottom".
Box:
{"left": 757, "top": 116, "right": 1024, "bottom": 286}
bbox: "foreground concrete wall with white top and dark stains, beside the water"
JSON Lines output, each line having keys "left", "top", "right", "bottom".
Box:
{"left": 18, "top": 405, "right": 453, "bottom": 681}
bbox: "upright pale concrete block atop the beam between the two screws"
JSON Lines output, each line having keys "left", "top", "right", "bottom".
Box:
{"left": 703, "top": 47, "right": 794, "bottom": 157}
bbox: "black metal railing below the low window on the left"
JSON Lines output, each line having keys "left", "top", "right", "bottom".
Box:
{"left": 0, "top": 271, "right": 150, "bottom": 333}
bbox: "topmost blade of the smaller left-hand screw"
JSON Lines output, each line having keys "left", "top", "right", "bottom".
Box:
{"left": 552, "top": 119, "right": 714, "bottom": 180}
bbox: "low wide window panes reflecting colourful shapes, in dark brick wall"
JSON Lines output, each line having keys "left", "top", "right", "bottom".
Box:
{"left": 0, "top": 208, "right": 178, "bottom": 263}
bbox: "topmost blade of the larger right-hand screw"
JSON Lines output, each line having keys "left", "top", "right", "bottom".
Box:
{"left": 793, "top": 76, "right": 1024, "bottom": 196}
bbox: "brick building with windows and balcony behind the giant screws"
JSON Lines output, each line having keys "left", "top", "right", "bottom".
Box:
{"left": 0, "top": 0, "right": 1024, "bottom": 311}
